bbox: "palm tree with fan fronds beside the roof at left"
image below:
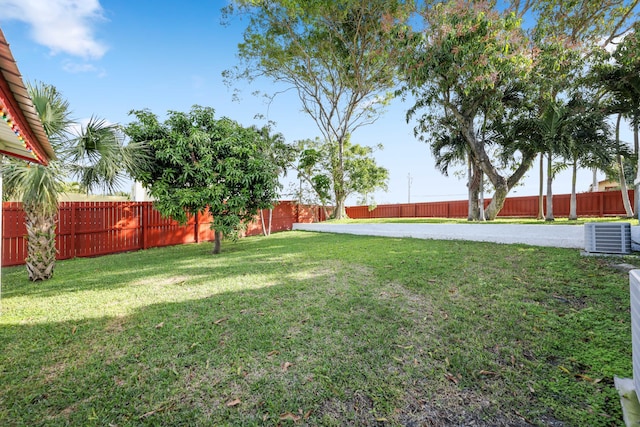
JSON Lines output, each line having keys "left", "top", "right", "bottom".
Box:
{"left": 2, "top": 83, "right": 135, "bottom": 281}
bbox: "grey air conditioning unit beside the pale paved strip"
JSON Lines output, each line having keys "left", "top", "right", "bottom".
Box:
{"left": 584, "top": 222, "right": 631, "bottom": 255}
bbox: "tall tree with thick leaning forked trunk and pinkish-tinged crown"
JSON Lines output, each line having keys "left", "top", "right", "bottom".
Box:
{"left": 404, "top": 1, "right": 535, "bottom": 219}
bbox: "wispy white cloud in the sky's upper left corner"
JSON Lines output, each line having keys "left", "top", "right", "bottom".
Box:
{"left": 0, "top": 0, "right": 107, "bottom": 59}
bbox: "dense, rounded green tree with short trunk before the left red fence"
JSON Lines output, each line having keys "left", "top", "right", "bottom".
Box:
{"left": 125, "top": 106, "right": 279, "bottom": 254}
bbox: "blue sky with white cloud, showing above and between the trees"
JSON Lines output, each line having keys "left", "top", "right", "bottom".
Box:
{"left": 0, "top": 0, "right": 620, "bottom": 204}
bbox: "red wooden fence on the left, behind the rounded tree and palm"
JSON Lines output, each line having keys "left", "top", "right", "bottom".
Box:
{"left": 2, "top": 201, "right": 325, "bottom": 266}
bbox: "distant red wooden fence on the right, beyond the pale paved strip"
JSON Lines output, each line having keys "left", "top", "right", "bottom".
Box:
{"left": 347, "top": 190, "right": 633, "bottom": 219}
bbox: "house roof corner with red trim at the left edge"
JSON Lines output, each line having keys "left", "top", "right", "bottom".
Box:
{"left": 0, "top": 25, "right": 55, "bottom": 165}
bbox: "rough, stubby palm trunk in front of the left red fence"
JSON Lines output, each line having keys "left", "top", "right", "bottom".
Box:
{"left": 24, "top": 204, "right": 56, "bottom": 282}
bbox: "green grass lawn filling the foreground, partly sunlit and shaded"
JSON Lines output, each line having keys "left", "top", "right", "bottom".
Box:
{"left": 0, "top": 232, "right": 634, "bottom": 426}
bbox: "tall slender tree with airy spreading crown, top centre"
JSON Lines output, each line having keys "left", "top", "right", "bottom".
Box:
{"left": 225, "top": 0, "right": 414, "bottom": 218}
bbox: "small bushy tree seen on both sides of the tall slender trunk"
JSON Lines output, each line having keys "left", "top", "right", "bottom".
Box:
{"left": 295, "top": 139, "right": 389, "bottom": 216}
